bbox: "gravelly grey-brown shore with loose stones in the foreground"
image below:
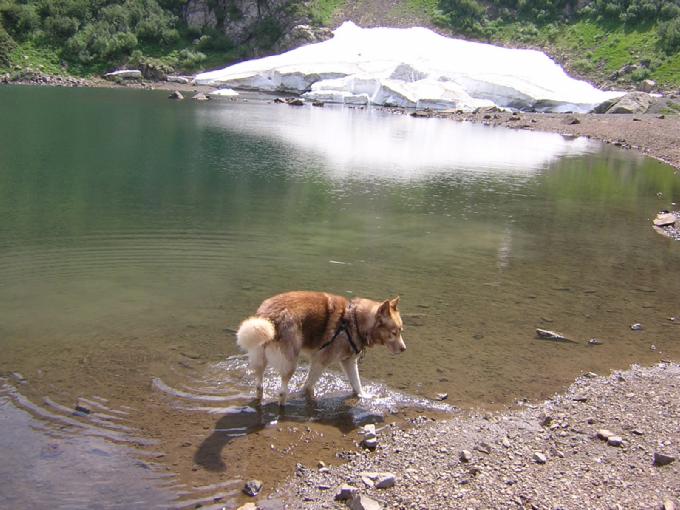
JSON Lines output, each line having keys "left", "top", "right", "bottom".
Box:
{"left": 268, "top": 362, "right": 680, "bottom": 510}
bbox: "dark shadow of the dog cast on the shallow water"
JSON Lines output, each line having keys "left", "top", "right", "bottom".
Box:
{"left": 194, "top": 395, "right": 384, "bottom": 471}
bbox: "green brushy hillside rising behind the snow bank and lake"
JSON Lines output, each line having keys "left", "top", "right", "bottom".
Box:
{"left": 0, "top": 0, "right": 680, "bottom": 90}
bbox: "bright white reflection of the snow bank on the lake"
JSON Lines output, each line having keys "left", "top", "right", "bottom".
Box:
{"left": 197, "top": 103, "right": 597, "bottom": 176}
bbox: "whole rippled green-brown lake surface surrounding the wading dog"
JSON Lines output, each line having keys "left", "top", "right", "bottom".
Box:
{"left": 0, "top": 87, "right": 680, "bottom": 508}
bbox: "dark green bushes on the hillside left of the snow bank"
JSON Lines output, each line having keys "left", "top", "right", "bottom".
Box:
{"left": 0, "top": 0, "right": 250, "bottom": 78}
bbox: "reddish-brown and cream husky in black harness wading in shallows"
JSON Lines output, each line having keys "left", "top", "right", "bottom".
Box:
{"left": 236, "top": 291, "right": 406, "bottom": 405}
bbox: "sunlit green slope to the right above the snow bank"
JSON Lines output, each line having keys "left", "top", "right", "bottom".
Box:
{"left": 434, "top": 0, "right": 680, "bottom": 87}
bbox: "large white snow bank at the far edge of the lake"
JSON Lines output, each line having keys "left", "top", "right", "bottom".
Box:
{"left": 196, "top": 22, "right": 623, "bottom": 111}
